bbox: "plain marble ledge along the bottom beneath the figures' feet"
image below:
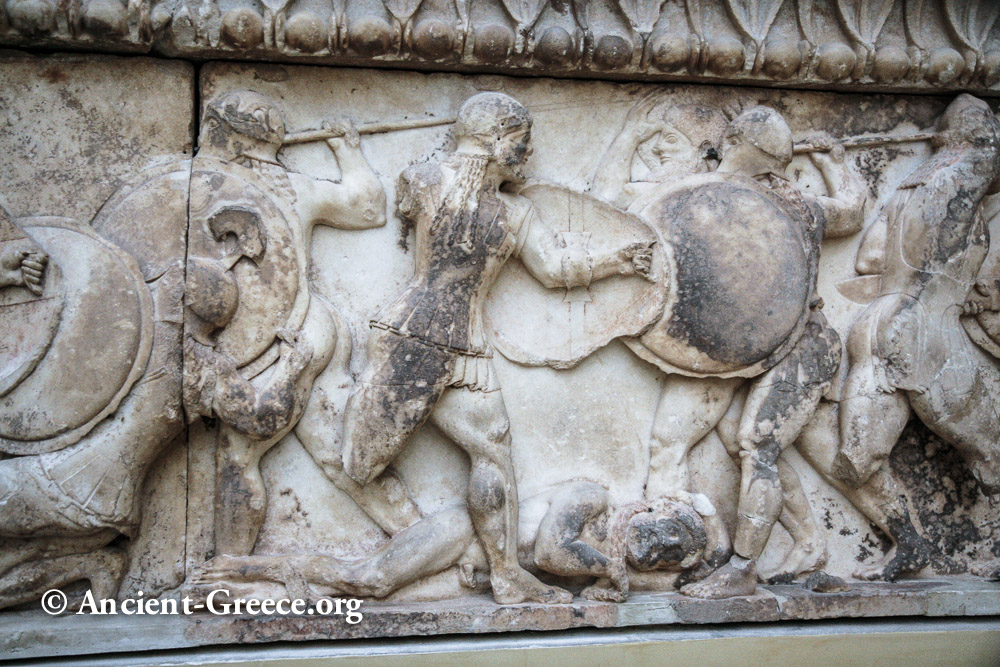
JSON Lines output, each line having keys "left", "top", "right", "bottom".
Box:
{"left": 0, "top": 579, "right": 1000, "bottom": 660}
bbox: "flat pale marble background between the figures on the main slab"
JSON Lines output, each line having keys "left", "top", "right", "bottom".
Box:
{"left": 189, "top": 64, "right": 997, "bottom": 595}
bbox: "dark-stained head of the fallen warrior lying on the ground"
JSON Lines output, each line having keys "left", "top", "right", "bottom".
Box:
{"left": 625, "top": 500, "right": 708, "bottom": 571}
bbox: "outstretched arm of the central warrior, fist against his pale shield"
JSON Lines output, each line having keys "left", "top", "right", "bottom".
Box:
{"left": 519, "top": 208, "right": 653, "bottom": 289}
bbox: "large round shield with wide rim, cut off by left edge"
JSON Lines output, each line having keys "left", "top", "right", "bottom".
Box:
{"left": 0, "top": 218, "right": 153, "bottom": 454}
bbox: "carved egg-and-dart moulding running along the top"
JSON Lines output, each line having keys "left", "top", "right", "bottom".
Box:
{"left": 0, "top": 0, "right": 1000, "bottom": 93}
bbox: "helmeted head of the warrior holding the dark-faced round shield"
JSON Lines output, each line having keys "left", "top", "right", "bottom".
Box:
{"left": 720, "top": 106, "right": 792, "bottom": 176}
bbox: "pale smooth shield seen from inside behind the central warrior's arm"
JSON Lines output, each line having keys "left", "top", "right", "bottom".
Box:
{"left": 485, "top": 183, "right": 669, "bottom": 368}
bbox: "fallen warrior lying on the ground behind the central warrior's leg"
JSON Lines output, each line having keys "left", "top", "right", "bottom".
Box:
{"left": 191, "top": 480, "right": 729, "bottom": 602}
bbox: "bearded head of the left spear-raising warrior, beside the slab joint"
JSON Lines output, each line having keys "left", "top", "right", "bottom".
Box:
{"left": 199, "top": 90, "right": 285, "bottom": 160}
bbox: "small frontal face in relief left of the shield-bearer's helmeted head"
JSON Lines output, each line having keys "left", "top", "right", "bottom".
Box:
{"left": 640, "top": 104, "right": 727, "bottom": 174}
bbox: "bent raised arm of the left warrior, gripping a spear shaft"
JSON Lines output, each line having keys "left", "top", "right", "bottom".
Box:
{"left": 289, "top": 123, "right": 386, "bottom": 229}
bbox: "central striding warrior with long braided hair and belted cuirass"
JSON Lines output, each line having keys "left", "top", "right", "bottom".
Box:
{"left": 343, "top": 93, "right": 652, "bottom": 604}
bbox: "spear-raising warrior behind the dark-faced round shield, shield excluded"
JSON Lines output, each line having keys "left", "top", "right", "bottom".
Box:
{"left": 668, "top": 107, "right": 866, "bottom": 598}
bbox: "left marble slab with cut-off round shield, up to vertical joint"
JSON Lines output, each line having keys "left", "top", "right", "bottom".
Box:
{"left": 0, "top": 54, "right": 194, "bottom": 607}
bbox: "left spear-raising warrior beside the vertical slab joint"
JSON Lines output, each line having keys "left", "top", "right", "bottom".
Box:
{"left": 185, "top": 91, "right": 419, "bottom": 567}
